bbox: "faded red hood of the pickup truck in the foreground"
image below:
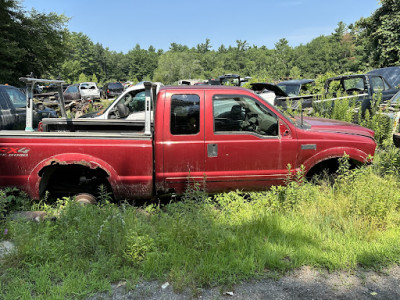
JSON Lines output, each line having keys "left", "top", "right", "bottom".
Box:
{"left": 296, "top": 117, "right": 374, "bottom": 138}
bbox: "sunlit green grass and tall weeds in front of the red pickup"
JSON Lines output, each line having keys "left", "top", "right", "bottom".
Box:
{"left": 0, "top": 148, "right": 400, "bottom": 299}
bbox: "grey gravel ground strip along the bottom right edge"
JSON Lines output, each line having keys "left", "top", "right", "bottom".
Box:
{"left": 89, "top": 266, "right": 400, "bottom": 300}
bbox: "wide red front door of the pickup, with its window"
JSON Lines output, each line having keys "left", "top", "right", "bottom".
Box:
{"left": 205, "top": 91, "right": 297, "bottom": 192}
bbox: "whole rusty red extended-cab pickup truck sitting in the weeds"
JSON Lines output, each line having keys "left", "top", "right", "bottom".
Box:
{"left": 0, "top": 83, "right": 376, "bottom": 199}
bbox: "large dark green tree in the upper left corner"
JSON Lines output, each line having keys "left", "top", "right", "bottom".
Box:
{"left": 0, "top": 0, "right": 68, "bottom": 84}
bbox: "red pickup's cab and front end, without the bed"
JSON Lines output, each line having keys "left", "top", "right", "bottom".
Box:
{"left": 154, "top": 86, "right": 376, "bottom": 192}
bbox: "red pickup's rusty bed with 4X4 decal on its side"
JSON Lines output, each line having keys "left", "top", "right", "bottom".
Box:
{"left": 0, "top": 128, "right": 153, "bottom": 199}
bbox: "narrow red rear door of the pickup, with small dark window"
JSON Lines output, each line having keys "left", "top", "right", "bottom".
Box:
{"left": 157, "top": 89, "right": 205, "bottom": 193}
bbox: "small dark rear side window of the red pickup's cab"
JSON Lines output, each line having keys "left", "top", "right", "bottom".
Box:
{"left": 170, "top": 94, "right": 200, "bottom": 135}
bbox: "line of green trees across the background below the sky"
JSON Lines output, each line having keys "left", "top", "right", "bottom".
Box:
{"left": 0, "top": 0, "right": 400, "bottom": 84}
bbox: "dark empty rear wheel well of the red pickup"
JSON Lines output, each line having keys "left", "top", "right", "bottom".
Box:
{"left": 39, "top": 164, "right": 112, "bottom": 198}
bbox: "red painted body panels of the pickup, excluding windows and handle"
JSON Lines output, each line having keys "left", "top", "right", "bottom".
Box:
{"left": 0, "top": 86, "right": 376, "bottom": 199}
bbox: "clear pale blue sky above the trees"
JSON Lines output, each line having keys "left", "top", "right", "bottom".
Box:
{"left": 21, "top": 0, "right": 379, "bottom": 53}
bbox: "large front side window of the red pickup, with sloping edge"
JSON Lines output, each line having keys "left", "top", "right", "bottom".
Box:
{"left": 213, "top": 95, "right": 278, "bottom": 136}
